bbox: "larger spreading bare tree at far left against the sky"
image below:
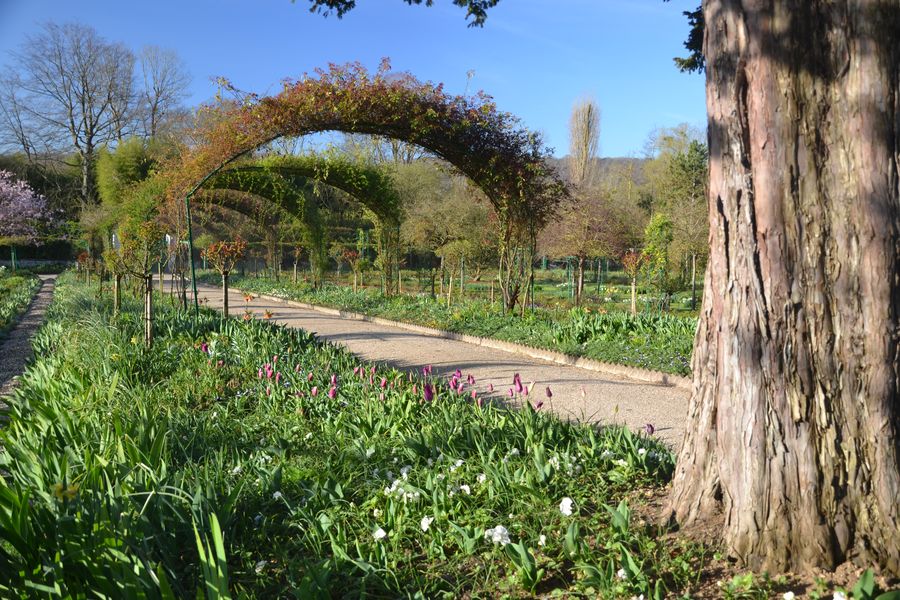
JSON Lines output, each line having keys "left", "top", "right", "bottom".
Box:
{"left": 2, "top": 23, "right": 134, "bottom": 206}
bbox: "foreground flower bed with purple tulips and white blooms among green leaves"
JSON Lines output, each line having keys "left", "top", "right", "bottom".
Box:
{"left": 0, "top": 275, "right": 705, "bottom": 598}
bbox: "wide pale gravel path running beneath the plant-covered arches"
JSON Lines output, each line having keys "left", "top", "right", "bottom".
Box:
{"left": 198, "top": 285, "right": 689, "bottom": 447}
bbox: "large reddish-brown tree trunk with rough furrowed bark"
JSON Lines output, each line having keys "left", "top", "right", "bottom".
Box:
{"left": 670, "top": 0, "right": 900, "bottom": 575}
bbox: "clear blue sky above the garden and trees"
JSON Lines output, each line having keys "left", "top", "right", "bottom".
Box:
{"left": 0, "top": 0, "right": 706, "bottom": 156}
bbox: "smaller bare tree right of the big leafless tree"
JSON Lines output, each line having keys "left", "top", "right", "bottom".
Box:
{"left": 140, "top": 46, "right": 191, "bottom": 137}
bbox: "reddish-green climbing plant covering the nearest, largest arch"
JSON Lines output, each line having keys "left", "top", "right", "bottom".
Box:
{"left": 169, "top": 61, "right": 566, "bottom": 308}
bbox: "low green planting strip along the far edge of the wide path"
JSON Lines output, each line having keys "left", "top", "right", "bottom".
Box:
{"left": 199, "top": 277, "right": 696, "bottom": 375}
